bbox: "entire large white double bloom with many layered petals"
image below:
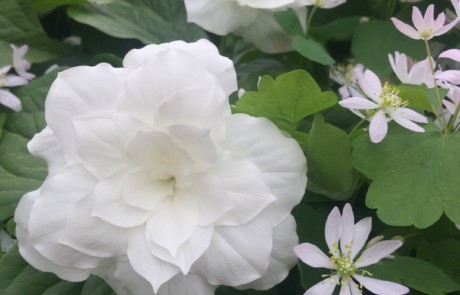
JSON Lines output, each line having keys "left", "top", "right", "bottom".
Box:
{"left": 15, "top": 40, "right": 306, "bottom": 295}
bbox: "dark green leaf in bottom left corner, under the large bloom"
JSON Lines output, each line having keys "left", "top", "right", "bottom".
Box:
{"left": 0, "top": 246, "right": 115, "bottom": 295}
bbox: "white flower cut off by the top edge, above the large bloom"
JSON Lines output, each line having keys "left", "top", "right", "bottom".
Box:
{"left": 185, "top": 0, "right": 307, "bottom": 53}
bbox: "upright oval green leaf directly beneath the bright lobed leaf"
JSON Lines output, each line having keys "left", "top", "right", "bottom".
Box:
{"left": 305, "top": 114, "right": 353, "bottom": 192}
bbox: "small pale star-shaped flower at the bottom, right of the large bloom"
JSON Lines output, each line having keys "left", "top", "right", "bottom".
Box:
{"left": 294, "top": 204, "right": 409, "bottom": 295}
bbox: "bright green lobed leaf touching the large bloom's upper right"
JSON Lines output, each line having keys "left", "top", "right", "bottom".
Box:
{"left": 235, "top": 70, "right": 337, "bottom": 131}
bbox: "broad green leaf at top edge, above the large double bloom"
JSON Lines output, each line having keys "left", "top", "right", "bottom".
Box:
{"left": 67, "top": 0, "right": 206, "bottom": 44}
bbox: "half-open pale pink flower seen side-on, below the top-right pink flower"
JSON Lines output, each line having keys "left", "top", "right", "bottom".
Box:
{"left": 388, "top": 51, "right": 434, "bottom": 88}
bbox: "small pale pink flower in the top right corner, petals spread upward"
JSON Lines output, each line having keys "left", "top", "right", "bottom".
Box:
{"left": 391, "top": 4, "right": 457, "bottom": 40}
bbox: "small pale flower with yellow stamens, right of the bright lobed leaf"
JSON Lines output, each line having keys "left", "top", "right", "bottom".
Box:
{"left": 339, "top": 70, "right": 428, "bottom": 143}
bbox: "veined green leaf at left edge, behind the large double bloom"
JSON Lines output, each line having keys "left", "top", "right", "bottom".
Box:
{"left": 0, "top": 73, "right": 56, "bottom": 221}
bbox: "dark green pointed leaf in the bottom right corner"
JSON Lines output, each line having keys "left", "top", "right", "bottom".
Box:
{"left": 366, "top": 256, "right": 460, "bottom": 295}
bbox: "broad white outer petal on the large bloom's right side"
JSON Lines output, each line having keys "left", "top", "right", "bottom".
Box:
{"left": 225, "top": 114, "right": 307, "bottom": 225}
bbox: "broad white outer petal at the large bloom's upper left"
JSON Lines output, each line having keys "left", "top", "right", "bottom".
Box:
{"left": 45, "top": 64, "right": 127, "bottom": 162}
